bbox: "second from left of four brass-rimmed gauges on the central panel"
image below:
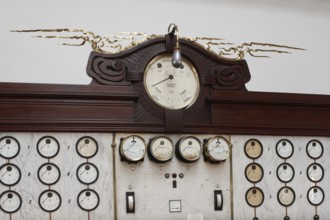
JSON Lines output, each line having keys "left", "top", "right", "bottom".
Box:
{"left": 148, "top": 136, "right": 174, "bottom": 162}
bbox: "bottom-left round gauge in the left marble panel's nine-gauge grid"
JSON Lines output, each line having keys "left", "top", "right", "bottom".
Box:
{"left": 0, "top": 190, "right": 22, "bottom": 213}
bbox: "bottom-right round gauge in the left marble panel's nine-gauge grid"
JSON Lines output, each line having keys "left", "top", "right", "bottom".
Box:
{"left": 77, "top": 189, "right": 100, "bottom": 211}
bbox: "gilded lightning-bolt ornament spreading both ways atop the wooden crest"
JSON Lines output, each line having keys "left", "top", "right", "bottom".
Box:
{"left": 11, "top": 24, "right": 305, "bottom": 60}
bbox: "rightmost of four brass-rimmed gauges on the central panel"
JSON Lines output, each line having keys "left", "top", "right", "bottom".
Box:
{"left": 204, "top": 136, "right": 229, "bottom": 162}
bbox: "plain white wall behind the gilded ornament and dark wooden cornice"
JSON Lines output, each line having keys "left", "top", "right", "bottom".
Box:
{"left": 0, "top": 0, "right": 330, "bottom": 94}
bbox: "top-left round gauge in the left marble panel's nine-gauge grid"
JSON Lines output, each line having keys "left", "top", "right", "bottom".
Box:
{"left": 0, "top": 136, "right": 20, "bottom": 159}
